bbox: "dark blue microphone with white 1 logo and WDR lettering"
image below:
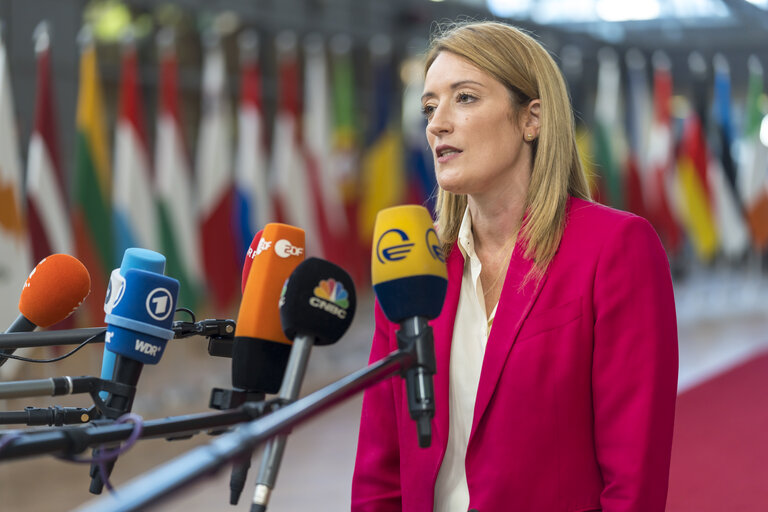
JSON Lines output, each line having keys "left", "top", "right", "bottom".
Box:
{"left": 90, "top": 268, "right": 179, "bottom": 494}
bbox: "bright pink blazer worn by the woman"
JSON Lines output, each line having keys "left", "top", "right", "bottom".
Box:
{"left": 352, "top": 198, "right": 678, "bottom": 512}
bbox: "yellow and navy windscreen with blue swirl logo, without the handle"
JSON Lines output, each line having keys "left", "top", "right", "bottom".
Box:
{"left": 371, "top": 205, "right": 448, "bottom": 323}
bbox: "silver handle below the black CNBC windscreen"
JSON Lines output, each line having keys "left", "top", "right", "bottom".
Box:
{"left": 251, "top": 334, "right": 315, "bottom": 512}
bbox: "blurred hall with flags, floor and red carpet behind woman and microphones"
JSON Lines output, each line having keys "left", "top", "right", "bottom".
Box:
{"left": 0, "top": 0, "right": 768, "bottom": 512}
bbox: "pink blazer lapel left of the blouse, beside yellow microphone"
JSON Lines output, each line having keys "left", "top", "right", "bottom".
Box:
{"left": 432, "top": 245, "right": 464, "bottom": 446}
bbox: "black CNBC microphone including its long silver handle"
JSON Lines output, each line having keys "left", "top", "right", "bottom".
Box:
{"left": 251, "top": 258, "right": 357, "bottom": 512}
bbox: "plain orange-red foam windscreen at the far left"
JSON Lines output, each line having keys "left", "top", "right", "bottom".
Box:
{"left": 19, "top": 254, "right": 91, "bottom": 327}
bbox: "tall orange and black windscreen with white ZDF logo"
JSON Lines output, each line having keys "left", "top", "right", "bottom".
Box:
{"left": 232, "top": 223, "right": 304, "bottom": 393}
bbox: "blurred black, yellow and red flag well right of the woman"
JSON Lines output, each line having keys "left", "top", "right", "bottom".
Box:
{"left": 677, "top": 52, "right": 719, "bottom": 261}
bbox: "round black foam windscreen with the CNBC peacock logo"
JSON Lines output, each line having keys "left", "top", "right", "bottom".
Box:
{"left": 280, "top": 258, "right": 357, "bottom": 345}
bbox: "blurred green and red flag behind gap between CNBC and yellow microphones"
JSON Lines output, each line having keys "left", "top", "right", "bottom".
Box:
{"left": 330, "top": 34, "right": 371, "bottom": 283}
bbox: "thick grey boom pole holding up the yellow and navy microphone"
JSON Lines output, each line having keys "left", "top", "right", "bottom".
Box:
{"left": 75, "top": 347, "right": 416, "bottom": 512}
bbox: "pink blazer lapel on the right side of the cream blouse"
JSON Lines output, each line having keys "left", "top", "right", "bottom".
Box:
{"left": 469, "top": 244, "right": 547, "bottom": 443}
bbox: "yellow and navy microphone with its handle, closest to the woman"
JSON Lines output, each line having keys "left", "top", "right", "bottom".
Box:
{"left": 371, "top": 205, "right": 448, "bottom": 448}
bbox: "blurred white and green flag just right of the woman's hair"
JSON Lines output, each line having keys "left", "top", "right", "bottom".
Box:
{"left": 592, "top": 47, "right": 626, "bottom": 208}
